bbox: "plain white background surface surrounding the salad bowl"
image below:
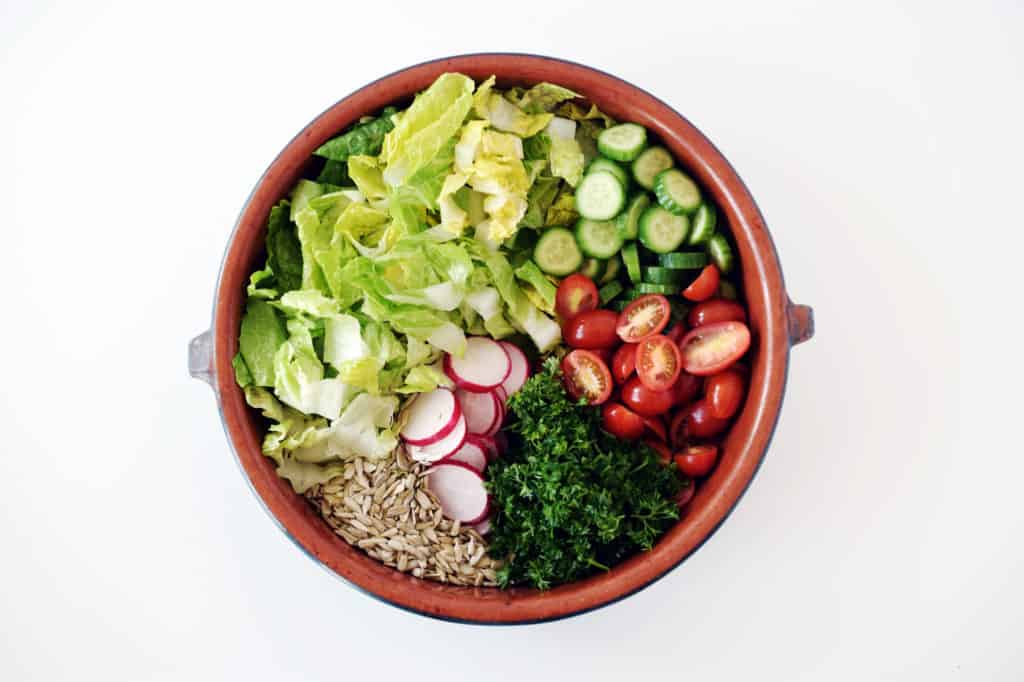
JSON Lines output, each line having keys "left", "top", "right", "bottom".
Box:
{"left": 0, "top": 0, "right": 1024, "bottom": 682}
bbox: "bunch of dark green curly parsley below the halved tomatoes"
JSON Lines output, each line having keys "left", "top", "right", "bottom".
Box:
{"left": 486, "top": 357, "right": 680, "bottom": 590}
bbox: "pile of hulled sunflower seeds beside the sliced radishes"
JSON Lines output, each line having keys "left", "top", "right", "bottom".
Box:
{"left": 306, "top": 447, "right": 501, "bottom": 587}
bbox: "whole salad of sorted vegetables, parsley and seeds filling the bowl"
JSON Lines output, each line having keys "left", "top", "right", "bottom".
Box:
{"left": 233, "top": 74, "right": 751, "bottom": 589}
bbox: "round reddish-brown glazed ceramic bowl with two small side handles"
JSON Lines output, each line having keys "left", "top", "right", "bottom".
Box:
{"left": 189, "top": 54, "right": 813, "bottom": 624}
